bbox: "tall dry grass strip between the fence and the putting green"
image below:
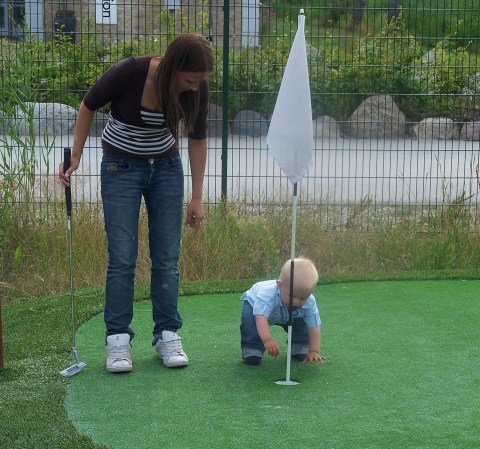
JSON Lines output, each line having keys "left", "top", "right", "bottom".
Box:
{"left": 0, "top": 192, "right": 480, "bottom": 302}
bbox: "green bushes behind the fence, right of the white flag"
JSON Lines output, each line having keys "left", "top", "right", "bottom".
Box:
{"left": 310, "top": 16, "right": 478, "bottom": 120}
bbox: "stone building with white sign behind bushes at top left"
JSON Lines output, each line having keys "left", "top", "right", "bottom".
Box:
{"left": 0, "top": 0, "right": 263, "bottom": 47}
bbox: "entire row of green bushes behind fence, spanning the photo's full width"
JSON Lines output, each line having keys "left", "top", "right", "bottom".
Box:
{"left": 0, "top": 6, "right": 479, "bottom": 124}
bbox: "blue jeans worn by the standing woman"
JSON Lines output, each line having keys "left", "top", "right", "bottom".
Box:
{"left": 101, "top": 153, "right": 184, "bottom": 339}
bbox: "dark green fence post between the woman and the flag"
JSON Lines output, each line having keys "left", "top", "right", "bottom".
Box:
{"left": 222, "top": 0, "right": 230, "bottom": 200}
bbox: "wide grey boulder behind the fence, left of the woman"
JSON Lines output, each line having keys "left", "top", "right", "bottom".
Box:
{"left": 12, "top": 103, "right": 77, "bottom": 136}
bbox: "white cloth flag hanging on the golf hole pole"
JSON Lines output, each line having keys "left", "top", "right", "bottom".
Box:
{"left": 267, "top": 14, "right": 313, "bottom": 184}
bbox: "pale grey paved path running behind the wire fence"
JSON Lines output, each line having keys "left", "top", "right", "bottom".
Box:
{"left": 6, "top": 136, "right": 480, "bottom": 205}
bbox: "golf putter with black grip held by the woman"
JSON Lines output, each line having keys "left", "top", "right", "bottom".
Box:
{"left": 60, "top": 148, "right": 86, "bottom": 377}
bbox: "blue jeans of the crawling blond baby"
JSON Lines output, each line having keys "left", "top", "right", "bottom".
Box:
{"left": 240, "top": 301, "right": 309, "bottom": 358}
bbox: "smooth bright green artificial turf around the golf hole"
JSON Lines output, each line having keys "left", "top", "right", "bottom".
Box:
{"left": 66, "top": 280, "right": 480, "bottom": 449}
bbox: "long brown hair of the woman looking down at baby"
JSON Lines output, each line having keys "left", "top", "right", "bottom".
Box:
{"left": 154, "top": 33, "right": 213, "bottom": 139}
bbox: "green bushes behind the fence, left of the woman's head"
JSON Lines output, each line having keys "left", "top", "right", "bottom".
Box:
{"left": 0, "top": 8, "right": 210, "bottom": 108}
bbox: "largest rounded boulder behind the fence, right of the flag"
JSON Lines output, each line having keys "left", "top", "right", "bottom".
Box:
{"left": 348, "top": 95, "right": 406, "bottom": 139}
